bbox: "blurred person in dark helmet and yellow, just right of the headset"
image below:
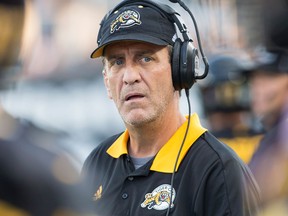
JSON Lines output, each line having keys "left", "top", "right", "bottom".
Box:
{"left": 201, "top": 53, "right": 262, "bottom": 163}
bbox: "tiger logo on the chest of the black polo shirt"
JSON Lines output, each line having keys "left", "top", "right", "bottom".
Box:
{"left": 141, "top": 184, "right": 176, "bottom": 210}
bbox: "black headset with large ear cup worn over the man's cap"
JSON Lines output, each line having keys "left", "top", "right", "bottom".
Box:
{"left": 98, "top": 0, "right": 209, "bottom": 90}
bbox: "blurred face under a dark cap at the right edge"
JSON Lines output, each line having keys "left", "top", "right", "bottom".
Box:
{"left": 250, "top": 71, "right": 288, "bottom": 126}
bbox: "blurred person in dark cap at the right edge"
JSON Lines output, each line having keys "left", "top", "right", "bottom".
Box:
{"left": 248, "top": 48, "right": 288, "bottom": 213}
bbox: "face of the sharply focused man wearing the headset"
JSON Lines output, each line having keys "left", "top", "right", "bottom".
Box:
{"left": 104, "top": 41, "right": 178, "bottom": 126}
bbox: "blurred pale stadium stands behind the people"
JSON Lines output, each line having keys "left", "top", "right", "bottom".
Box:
{"left": 0, "top": 0, "right": 281, "bottom": 169}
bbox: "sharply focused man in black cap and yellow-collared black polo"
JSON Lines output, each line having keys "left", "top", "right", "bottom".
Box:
{"left": 83, "top": 1, "right": 258, "bottom": 216}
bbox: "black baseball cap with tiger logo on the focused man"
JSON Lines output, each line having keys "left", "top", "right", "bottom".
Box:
{"left": 91, "top": 2, "right": 176, "bottom": 58}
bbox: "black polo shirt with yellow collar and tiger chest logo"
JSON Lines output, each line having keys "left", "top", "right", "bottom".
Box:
{"left": 83, "top": 114, "right": 258, "bottom": 216}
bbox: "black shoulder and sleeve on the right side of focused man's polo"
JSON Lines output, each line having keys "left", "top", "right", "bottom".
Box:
{"left": 192, "top": 131, "right": 259, "bottom": 215}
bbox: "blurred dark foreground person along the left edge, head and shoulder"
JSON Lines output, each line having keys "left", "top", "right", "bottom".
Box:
{"left": 0, "top": 0, "right": 96, "bottom": 216}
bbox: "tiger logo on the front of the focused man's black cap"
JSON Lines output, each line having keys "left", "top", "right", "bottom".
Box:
{"left": 110, "top": 10, "right": 141, "bottom": 34}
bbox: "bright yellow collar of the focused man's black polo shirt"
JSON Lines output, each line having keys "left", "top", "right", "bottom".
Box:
{"left": 107, "top": 113, "right": 207, "bottom": 173}
